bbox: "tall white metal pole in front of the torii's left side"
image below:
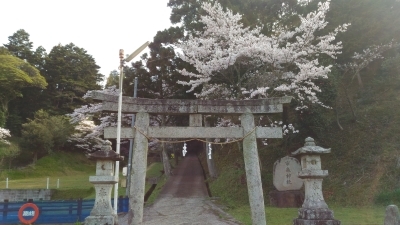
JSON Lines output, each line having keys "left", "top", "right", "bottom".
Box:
{"left": 114, "top": 49, "right": 124, "bottom": 214}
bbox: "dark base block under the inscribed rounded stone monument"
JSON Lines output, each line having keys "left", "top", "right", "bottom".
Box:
{"left": 269, "top": 190, "right": 304, "bottom": 208}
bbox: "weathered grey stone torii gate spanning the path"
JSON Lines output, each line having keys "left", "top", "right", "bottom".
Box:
{"left": 93, "top": 92, "right": 291, "bottom": 225}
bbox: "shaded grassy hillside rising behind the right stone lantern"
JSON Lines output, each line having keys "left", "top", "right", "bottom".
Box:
{"left": 201, "top": 62, "right": 400, "bottom": 206}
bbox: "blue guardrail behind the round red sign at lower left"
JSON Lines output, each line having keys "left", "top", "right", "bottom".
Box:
{"left": 0, "top": 197, "right": 129, "bottom": 224}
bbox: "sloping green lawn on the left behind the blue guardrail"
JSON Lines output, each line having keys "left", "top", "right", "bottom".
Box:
{"left": 0, "top": 152, "right": 166, "bottom": 201}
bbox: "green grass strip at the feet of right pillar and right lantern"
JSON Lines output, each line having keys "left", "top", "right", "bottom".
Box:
{"left": 228, "top": 206, "right": 385, "bottom": 225}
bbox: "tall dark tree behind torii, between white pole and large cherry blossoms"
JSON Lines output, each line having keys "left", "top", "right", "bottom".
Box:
{"left": 124, "top": 27, "right": 193, "bottom": 175}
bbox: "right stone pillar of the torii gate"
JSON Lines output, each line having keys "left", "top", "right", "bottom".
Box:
{"left": 240, "top": 113, "right": 267, "bottom": 225}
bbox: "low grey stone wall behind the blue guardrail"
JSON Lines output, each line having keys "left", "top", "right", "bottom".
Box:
{"left": 0, "top": 189, "right": 53, "bottom": 202}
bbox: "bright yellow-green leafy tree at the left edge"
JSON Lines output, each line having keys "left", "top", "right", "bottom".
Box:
{"left": 0, "top": 50, "right": 47, "bottom": 123}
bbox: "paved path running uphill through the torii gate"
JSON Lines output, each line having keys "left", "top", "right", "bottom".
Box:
{"left": 119, "top": 155, "right": 239, "bottom": 225}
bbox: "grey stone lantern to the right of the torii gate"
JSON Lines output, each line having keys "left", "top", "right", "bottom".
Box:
{"left": 292, "top": 137, "right": 341, "bottom": 225}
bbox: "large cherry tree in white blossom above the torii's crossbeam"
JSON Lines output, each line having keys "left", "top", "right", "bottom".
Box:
{"left": 176, "top": 0, "right": 349, "bottom": 108}
